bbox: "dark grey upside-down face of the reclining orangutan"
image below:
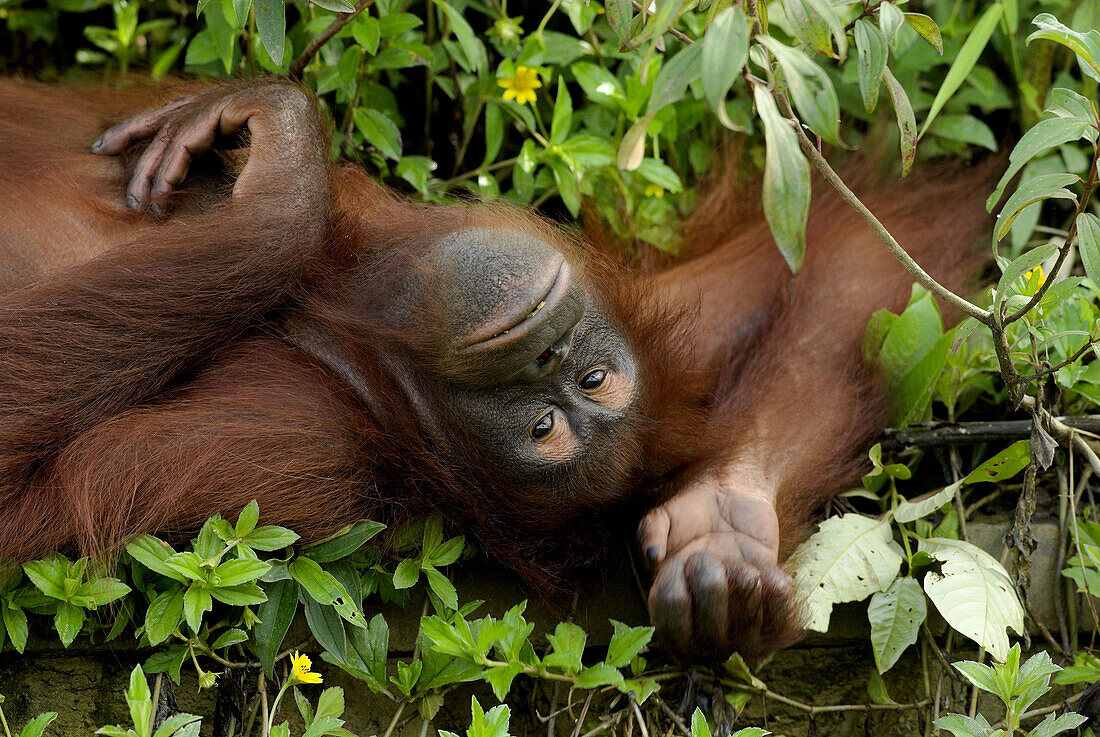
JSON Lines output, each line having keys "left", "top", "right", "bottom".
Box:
{"left": 411, "top": 229, "right": 639, "bottom": 510}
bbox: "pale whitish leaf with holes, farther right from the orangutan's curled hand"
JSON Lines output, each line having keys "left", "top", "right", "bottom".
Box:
{"left": 920, "top": 538, "right": 1024, "bottom": 661}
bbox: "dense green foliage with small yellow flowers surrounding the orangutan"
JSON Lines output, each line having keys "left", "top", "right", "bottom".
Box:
{"left": 0, "top": 0, "right": 1100, "bottom": 737}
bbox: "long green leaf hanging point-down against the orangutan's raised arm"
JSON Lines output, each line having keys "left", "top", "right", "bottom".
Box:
{"left": 752, "top": 86, "right": 810, "bottom": 274}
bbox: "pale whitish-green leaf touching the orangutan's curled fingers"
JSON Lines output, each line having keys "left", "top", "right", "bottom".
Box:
{"left": 789, "top": 515, "right": 902, "bottom": 633}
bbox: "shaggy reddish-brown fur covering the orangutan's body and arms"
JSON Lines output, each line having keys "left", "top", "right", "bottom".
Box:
{"left": 0, "top": 81, "right": 990, "bottom": 655}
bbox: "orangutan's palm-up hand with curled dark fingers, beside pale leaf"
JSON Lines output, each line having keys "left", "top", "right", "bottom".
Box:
{"left": 638, "top": 474, "right": 802, "bottom": 662}
